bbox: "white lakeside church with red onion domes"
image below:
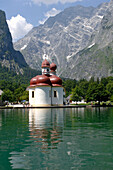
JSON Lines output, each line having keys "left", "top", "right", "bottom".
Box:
{"left": 29, "top": 59, "right": 64, "bottom": 107}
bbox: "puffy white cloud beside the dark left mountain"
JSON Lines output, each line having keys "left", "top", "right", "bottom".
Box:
{"left": 7, "top": 14, "right": 33, "bottom": 42}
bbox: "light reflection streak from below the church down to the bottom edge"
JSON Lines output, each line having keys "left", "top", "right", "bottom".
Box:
{"left": 9, "top": 109, "right": 64, "bottom": 169}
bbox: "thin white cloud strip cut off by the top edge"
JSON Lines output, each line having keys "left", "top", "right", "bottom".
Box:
{"left": 31, "top": 0, "right": 82, "bottom": 5}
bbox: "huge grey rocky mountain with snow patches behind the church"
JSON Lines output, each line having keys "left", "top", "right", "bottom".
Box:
{"left": 14, "top": 0, "right": 113, "bottom": 79}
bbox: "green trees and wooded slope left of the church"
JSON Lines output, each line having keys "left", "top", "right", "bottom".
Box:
{"left": 0, "top": 65, "right": 41, "bottom": 102}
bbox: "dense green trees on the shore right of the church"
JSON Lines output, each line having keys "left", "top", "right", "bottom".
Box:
{"left": 70, "top": 77, "right": 113, "bottom": 104}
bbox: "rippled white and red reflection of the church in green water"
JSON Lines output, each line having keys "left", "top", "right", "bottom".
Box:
{"left": 29, "top": 109, "right": 64, "bottom": 152}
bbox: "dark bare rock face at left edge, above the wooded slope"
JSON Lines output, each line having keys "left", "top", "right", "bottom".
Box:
{"left": 0, "top": 10, "right": 27, "bottom": 74}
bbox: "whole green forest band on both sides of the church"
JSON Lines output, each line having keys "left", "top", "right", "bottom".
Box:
{"left": 0, "top": 63, "right": 113, "bottom": 104}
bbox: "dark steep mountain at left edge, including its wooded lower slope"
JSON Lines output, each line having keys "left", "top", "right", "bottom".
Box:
{"left": 0, "top": 10, "right": 41, "bottom": 84}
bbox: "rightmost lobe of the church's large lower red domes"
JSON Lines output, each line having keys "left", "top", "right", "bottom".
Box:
{"left": 50, "top": 75, "right": 62, "bottom": 86}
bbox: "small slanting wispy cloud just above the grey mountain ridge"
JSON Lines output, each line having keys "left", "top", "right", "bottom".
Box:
{"left": 39, "top": 8, "right": 61, "bottom": 24}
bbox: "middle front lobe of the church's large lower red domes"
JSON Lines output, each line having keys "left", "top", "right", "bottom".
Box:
{"left": 36, "top": 74, "right": 51, "bottom": 86}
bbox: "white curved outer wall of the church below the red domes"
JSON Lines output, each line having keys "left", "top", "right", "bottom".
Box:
{"left": 29, "top": 86, "right": 63, "bottom": 106}
